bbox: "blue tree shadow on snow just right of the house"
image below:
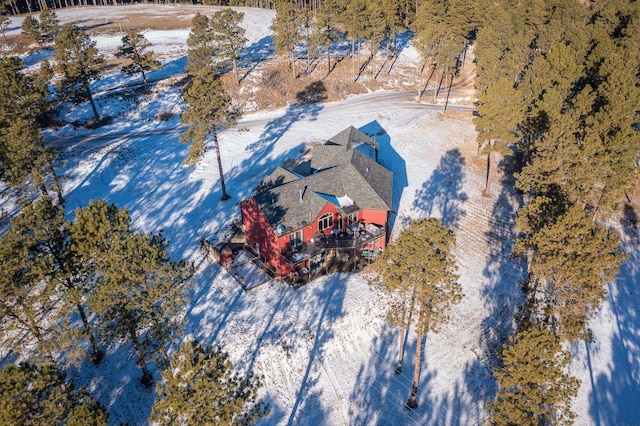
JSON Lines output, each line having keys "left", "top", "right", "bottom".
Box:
{"left": 413, "top": 148, "right": 468, "bottom": 229}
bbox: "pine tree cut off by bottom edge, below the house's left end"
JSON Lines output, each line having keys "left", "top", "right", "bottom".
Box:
{"left": 151, "top": 341, "right": 269, "bottom": 426}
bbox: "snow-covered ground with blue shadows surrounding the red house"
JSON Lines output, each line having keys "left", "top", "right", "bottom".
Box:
{"left": 0, "top": 6, "right": 640, "bottom": 425}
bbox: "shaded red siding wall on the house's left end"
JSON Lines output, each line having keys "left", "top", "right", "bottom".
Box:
{"left": 240, "top": 198, "right": 281, "bottom": 274}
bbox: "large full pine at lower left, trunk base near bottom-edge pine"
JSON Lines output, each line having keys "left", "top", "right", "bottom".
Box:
{"left": 70, "top": 200, "right": 193, "bottom": 386}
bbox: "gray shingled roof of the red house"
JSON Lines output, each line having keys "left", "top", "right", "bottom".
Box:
{"left": 254, "top": 127, "right": 393, "bottom": 233}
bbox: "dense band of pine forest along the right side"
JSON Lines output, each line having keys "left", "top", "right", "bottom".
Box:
{"left": 474, "top": 0, "right": 640, "bottom": 425}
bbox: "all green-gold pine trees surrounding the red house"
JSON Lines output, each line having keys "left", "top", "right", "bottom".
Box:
{"left": 0, "top": 0, "right": 640, "bottom": 424}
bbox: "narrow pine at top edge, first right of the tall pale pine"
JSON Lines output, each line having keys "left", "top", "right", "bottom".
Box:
{"left": 269, "top": 0, "right": 301, "bottom": 78}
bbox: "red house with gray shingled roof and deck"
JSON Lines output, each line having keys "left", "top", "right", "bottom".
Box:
{"left": 240, "top": 127, "right": 393, "bottom": 277}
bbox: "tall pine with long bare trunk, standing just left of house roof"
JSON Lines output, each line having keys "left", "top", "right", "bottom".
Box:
{"left": 180, "top": 67, "right": 239, "bottom": 200}
